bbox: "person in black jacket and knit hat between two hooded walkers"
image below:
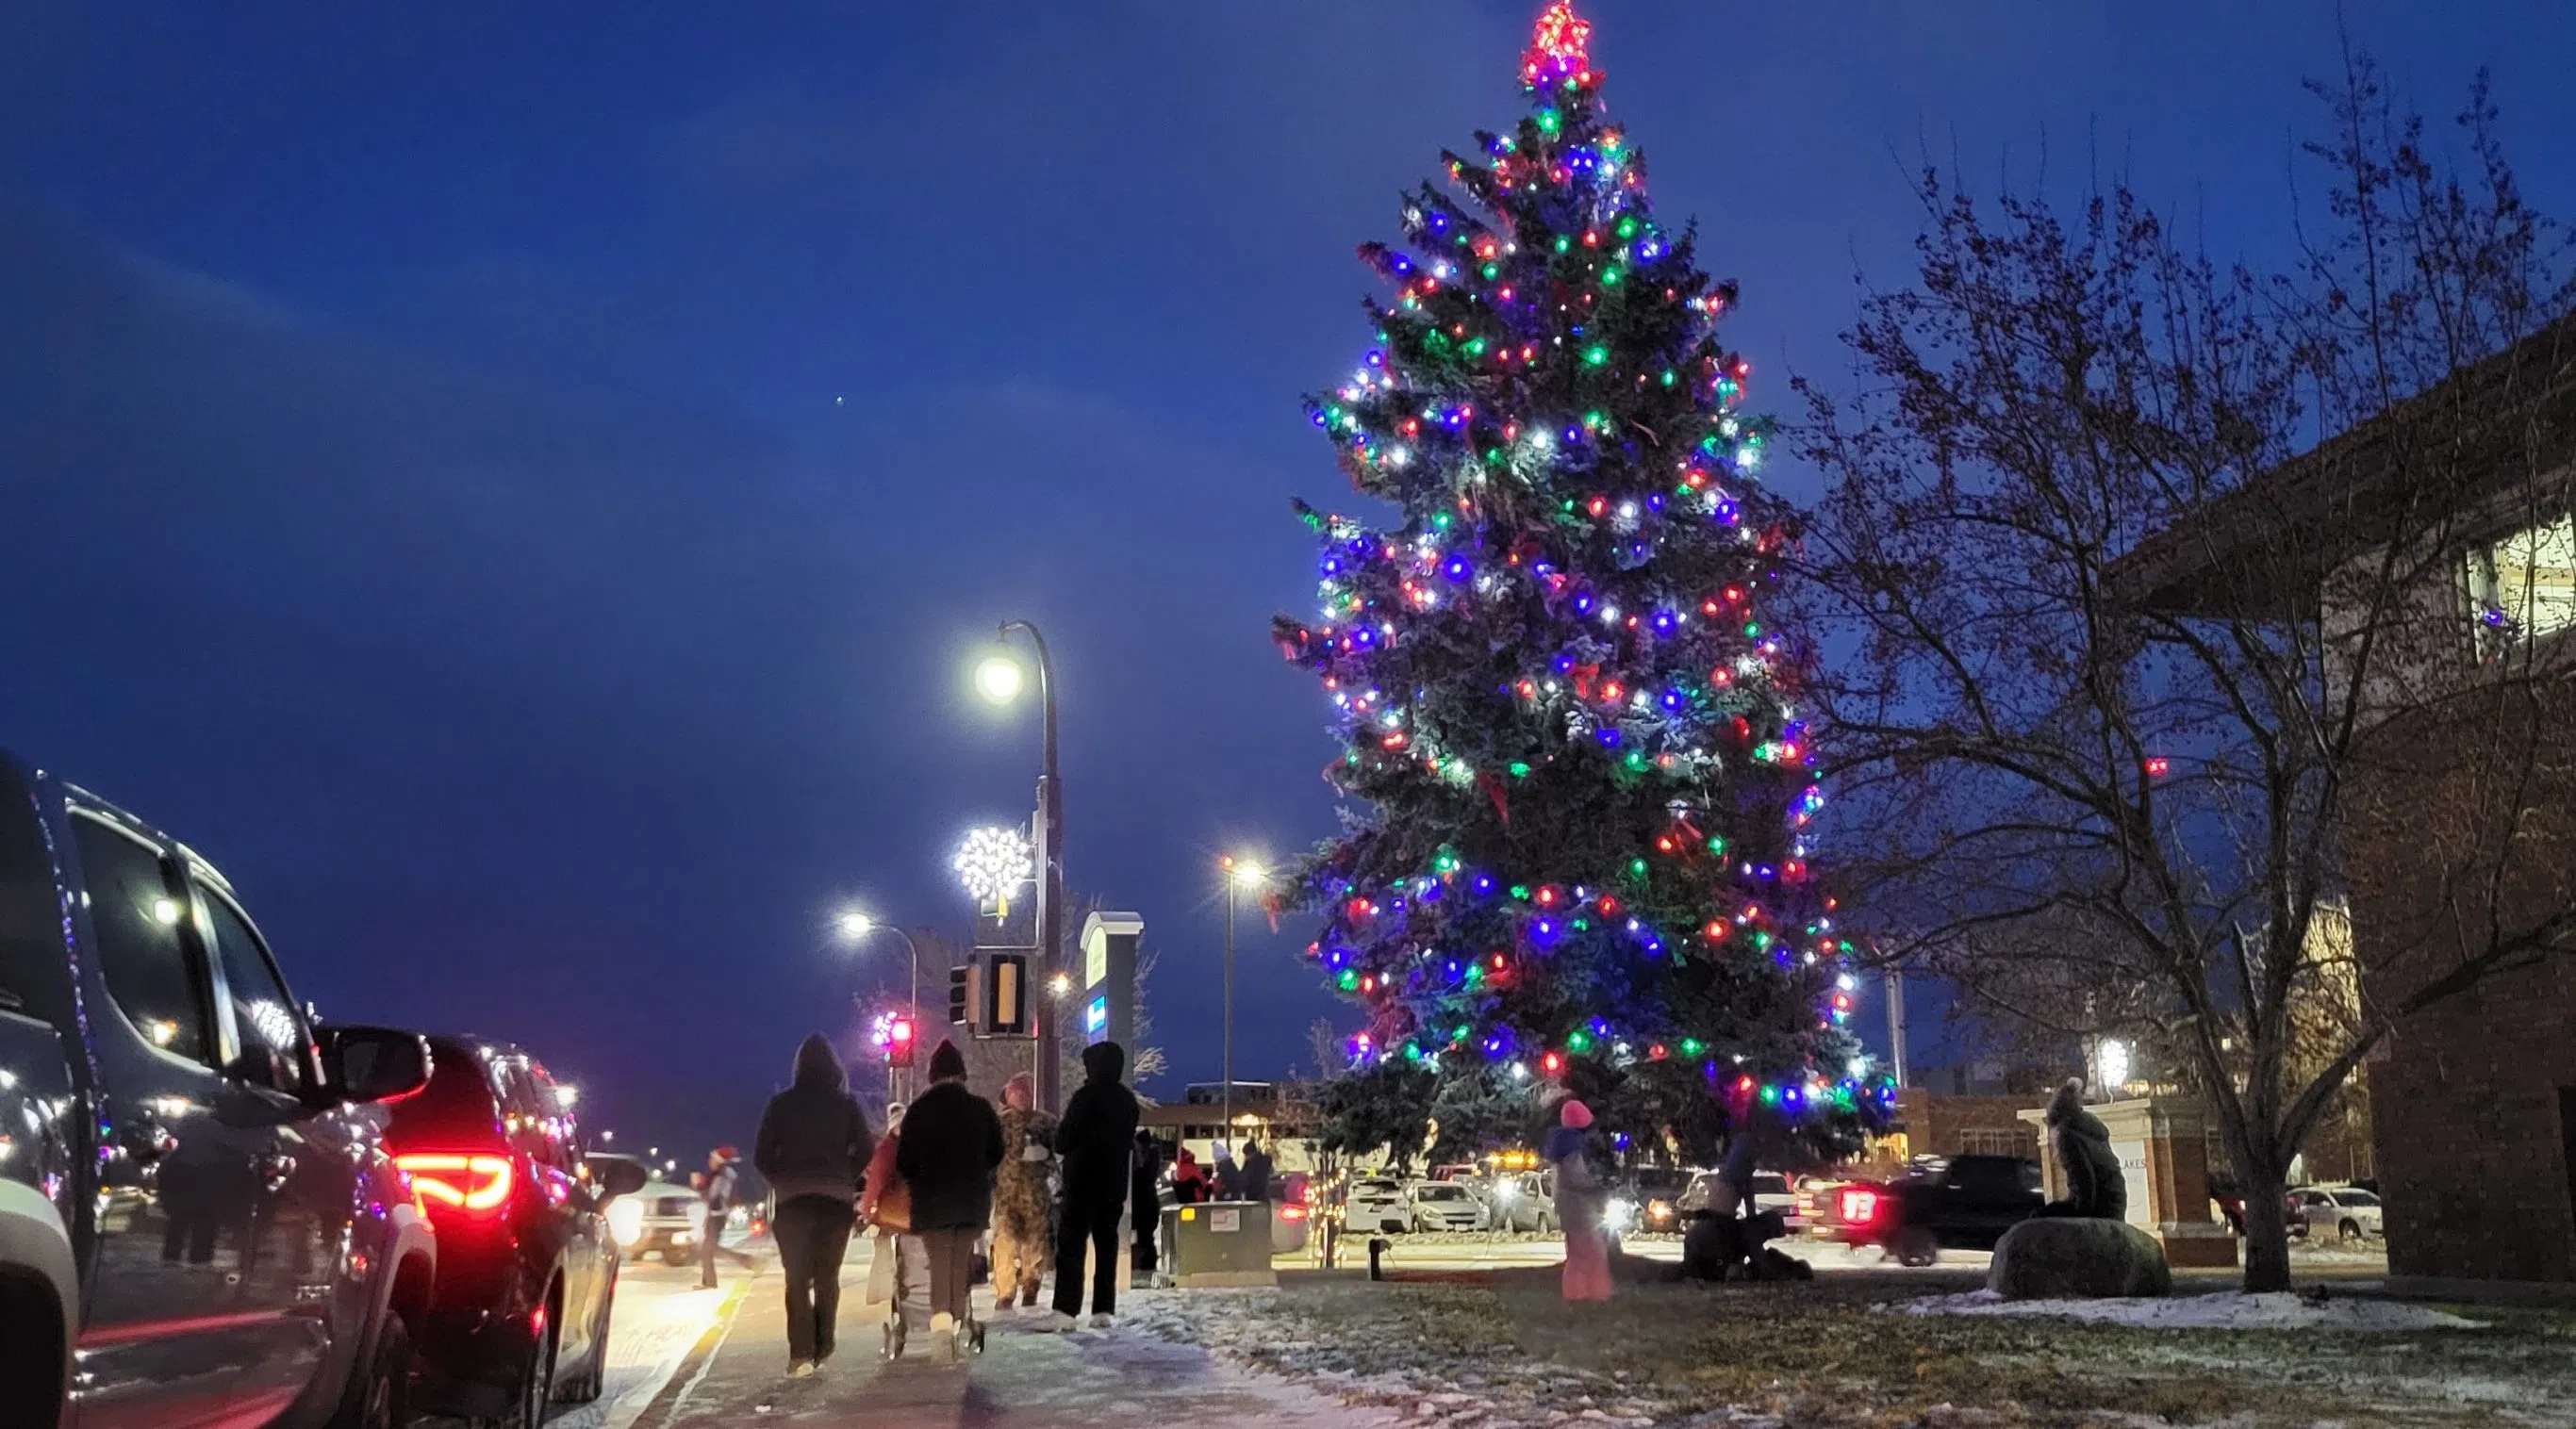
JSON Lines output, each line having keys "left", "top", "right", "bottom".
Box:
{"left": 894, "top": 1041, "right": 1002, "bottom": 1365}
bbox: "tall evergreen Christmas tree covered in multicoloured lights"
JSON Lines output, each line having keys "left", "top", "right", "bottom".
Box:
{"left": 1278, "top": 0, "right": 1891, "bottom": 1158}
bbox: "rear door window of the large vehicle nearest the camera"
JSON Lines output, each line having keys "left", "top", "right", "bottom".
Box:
{"left": 72, "top": 816, "right": 216, "bottom": 1066}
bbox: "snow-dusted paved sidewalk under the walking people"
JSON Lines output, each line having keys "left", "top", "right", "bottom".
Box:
{"left": 636, "top": 1246, "right": 1394, "bottom": 1429}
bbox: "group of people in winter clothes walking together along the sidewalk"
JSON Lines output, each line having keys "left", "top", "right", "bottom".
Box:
{"left": 752, "top": 1032, "right": 1151, "bottom": 1377}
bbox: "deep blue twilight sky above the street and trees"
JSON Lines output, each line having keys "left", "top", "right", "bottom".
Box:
{"left": 0, "top": 0, "right": 2576, "bottom": 1138}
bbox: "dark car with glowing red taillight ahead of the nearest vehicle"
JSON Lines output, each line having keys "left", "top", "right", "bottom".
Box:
{"left": 353, "top": 1035, "right": 644, "bottom": 1429}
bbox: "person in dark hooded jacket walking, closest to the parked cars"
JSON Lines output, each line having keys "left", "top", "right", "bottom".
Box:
{"left": 752, "top": 1032, "right": 876, "bottom": 1377}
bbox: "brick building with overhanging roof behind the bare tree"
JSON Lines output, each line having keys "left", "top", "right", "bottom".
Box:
{"left": 2115, "top": 320, "right": 2576, "bottom": 1298}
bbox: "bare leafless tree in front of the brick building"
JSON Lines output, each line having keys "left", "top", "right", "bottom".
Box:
{"left": 1801, "top": 59, "right": 2576, "bottom": 1289}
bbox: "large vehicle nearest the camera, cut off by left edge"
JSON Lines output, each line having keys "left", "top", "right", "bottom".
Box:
{"left": 0, "top": 752, "right": 438, "bottom": 1429}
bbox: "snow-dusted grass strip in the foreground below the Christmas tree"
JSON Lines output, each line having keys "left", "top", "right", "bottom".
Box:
{"left": 1136, "top": 1270, "right": 2576, "bottom": 1429}
